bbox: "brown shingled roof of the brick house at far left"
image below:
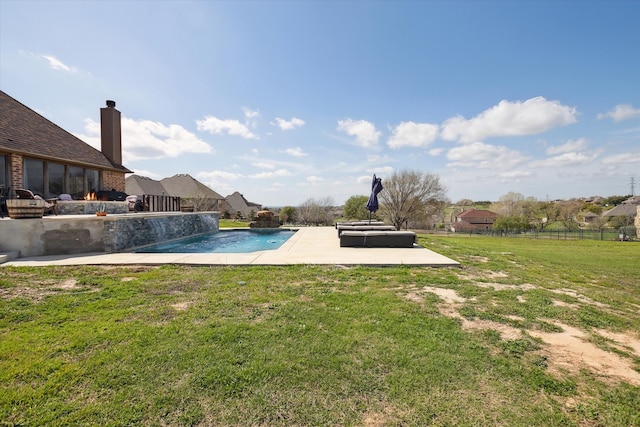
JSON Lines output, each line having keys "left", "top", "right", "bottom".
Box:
{"left": 0, "top": 91, "right": 131, "bottom": 173}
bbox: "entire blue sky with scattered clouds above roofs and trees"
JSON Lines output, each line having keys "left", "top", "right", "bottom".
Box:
{"left": 0, "top": 0, "right": 640, "bottom": 206}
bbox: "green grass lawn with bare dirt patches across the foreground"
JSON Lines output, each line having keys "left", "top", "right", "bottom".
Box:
{"left": 0, "top": 236, "right": 640, "bottom": 427}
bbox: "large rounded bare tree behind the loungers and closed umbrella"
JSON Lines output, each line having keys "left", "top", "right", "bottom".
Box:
{"left": 378, "top": 170, "right": 446, "bottom": 229}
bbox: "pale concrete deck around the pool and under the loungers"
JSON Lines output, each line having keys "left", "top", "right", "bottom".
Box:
{"left": 0, "top": 227, "right": 460, "bottom": 267}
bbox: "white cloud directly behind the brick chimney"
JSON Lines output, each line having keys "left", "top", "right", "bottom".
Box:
{"left": 76, "top": 117, "right": 215, "bottom": 164}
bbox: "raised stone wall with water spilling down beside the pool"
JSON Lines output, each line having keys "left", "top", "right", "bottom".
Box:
{"left": 0, "top": 212, "right": 219, "bottom": 257}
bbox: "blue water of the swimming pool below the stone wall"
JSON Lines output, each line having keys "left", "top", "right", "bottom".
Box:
{"left": 135, "top": 229, "right": 295, "bottom": 253}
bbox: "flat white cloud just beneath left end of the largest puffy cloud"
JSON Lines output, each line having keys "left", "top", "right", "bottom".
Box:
{"left": 447, "top": 142, "right": 526, "bottom": 169}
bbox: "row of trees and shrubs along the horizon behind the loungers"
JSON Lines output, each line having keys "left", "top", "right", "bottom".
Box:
{"left": 272, "top": 170, "right": 633, "bottom": 231}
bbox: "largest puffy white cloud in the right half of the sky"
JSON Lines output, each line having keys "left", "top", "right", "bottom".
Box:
{"left": 441, "top": 97, "right": 578, "bottom": 144}
